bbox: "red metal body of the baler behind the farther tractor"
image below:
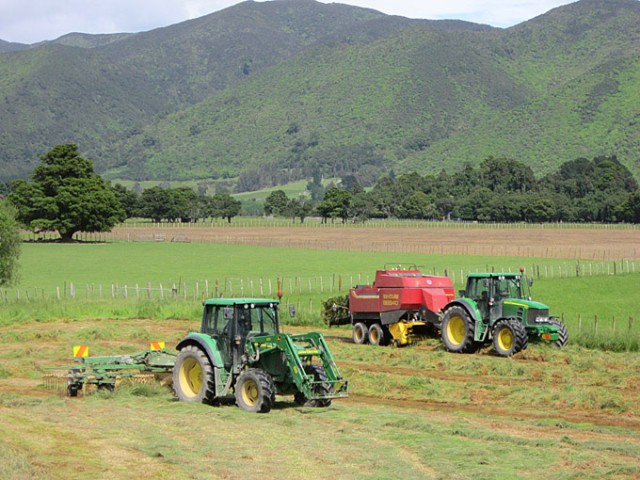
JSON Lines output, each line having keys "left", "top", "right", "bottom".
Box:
{"left": 349, "top": 270, "right": 455, "bottom": 313}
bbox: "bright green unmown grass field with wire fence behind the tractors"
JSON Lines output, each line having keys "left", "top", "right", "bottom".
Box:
{"left": 5, "top": 242, "right": 640, "bottom": 350}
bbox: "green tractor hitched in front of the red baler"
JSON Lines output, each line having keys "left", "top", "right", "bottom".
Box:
{"left": 440, "top": 271, "right": 569, "bottom": 357}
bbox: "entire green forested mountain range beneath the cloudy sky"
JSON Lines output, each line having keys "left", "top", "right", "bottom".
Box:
{"left": 0, "top": 0, "right": 640, "bottom": 190}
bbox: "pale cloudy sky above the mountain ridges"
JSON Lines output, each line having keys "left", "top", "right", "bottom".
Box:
{"left": 0, "top": 0, "right": 575, "bottom": 44}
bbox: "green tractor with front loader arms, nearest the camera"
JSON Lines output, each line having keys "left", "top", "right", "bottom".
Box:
{"left": 173, "top": 298, "right": 347, "bottom": 413}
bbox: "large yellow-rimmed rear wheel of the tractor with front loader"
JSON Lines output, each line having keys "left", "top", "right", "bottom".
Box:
{"left": 173, "top": 345, "right": 216, "bottom": 403}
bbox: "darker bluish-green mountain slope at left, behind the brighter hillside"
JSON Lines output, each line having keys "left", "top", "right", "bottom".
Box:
{"left": 0, "top": 1, "right": 412, "bottom": 179}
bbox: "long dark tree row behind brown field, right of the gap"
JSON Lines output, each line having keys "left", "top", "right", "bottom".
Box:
{"left": 264, "top": 156, "right": 640, "bottom": 223}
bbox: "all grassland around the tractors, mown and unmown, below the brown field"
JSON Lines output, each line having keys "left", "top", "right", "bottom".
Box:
{"left": 0, "top": 223, "right": 640, "bottom": 479}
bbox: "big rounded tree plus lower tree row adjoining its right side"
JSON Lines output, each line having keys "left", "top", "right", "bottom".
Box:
{"left": 8, "top": 144, "right": 241, "bottom": 241}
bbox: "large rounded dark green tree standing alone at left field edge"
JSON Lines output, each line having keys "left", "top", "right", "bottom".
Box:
{"left": 9, "top": 144, "right": 125, "bottom": 241}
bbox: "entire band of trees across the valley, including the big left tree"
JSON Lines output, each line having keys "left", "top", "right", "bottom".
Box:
{"left": 4, "top": 144, "right": 640, "bottom": 260}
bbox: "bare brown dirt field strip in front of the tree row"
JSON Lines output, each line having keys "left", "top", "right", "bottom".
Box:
{"left": 107, "top": 225, "right": 640, "bottom": 260}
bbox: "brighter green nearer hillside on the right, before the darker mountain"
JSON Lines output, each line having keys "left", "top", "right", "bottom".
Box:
{"left": 112, "top": 0, "right": 640, "bottom": 183}
